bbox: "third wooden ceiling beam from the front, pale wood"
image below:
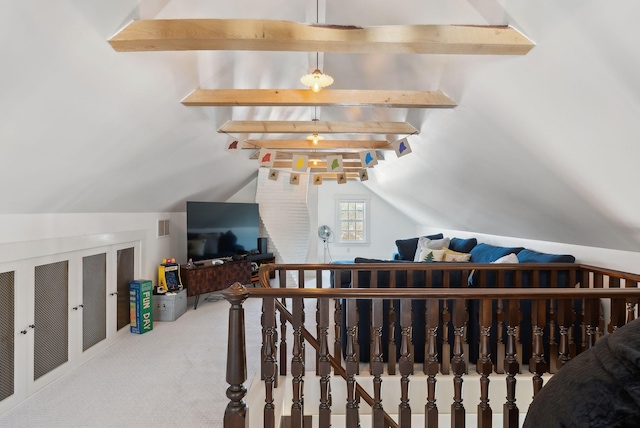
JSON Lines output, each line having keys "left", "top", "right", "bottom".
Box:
{"left": 218, "top": 120, "right": 418, "bottom": 135}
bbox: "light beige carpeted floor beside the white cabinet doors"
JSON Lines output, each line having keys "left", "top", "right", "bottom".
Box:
{"left": 0, "top": 296, "right": 261, "bottom": 428}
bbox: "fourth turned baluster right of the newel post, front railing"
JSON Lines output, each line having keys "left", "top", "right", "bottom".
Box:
{"left": 344, "top": 299, "right": 360, "bottom": 427}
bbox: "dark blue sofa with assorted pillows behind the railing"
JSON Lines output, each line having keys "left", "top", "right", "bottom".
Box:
{"left": 332, "top": 234, "right": 575, "bottom": 362}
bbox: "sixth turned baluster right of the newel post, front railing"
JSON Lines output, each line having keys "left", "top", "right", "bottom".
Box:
{"left": 398, "top": 299, "right": 413, "bottom": 428}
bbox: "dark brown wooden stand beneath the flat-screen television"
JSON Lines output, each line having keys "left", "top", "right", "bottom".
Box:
{"left": 180, "top": 260, "right": 253, "bottom": 309}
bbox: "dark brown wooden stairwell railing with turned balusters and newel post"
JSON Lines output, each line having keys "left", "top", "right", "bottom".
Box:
{"left": 223, "top": 263, "right": 640, "bottom": 428}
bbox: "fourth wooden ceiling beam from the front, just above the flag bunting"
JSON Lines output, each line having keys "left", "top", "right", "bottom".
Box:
{"left": 240, "top": 140, "right": 393, "bottom": 151}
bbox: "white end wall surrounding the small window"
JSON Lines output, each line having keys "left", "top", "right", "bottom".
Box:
{"left": 311, "top": 181, "right": 417, "bottom": 263}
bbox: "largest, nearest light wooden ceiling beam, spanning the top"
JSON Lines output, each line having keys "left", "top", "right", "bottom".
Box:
{"left": 109, "top": 19, "right": 534, "bottom": 55}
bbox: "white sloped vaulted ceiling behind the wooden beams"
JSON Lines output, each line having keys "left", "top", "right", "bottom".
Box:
{"left": 0, "top": 0, "right": 640, "bottom": 251}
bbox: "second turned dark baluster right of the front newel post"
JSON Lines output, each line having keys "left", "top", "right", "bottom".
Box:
{"left": 291, "top": 297, "right": 304, "bottom": 428}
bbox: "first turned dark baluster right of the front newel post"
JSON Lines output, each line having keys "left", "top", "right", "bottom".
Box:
{"left": 262, "top": 297, "right": 277, "bottom": 428}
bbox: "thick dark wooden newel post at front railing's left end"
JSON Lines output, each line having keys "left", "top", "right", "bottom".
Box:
{"left": 222, "top": 282, "right": 249, "bottom": 428}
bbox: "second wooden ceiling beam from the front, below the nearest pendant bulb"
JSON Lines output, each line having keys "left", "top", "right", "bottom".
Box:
{"left": 182, "top": 89, "right": 456, "bottom": 108}
